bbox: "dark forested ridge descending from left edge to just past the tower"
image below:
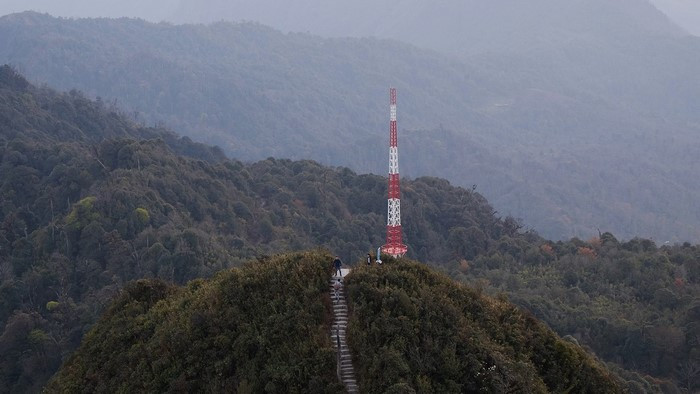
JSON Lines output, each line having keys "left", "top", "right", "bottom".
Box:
{"left": 0, "top": 67, "right": 521, "bottom": 391}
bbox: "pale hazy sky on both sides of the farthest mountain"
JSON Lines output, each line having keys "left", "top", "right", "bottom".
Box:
{"left": 0, "top": 0, "right": 700, "bottom": 36}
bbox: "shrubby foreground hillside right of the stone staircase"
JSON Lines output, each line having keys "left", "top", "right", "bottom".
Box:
{"left": 346, "top": 259, "right": 622, "bottom": 393}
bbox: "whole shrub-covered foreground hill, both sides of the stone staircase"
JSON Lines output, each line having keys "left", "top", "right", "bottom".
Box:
{"left": 48, "top": 252, "right": 622, "bottom": 393}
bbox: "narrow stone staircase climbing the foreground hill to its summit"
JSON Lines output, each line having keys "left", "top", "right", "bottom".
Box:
{"left": 329, "top": 273, "right": 360, "bottom": 393}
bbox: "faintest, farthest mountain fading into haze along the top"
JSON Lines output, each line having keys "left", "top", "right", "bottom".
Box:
{"left": 169, "top": 0, "right": 684, "bottom": 55}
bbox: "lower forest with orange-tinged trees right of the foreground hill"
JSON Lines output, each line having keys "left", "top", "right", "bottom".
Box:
{"left": 448, "top": 233, "right": 700, "bottom": 392}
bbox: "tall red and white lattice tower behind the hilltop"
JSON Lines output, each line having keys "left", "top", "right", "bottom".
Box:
{"left": 382, "top": 88, "right": 408, "bottom": 257}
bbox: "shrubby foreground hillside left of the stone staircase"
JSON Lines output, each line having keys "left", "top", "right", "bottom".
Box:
{"left": 47, "top": 252, "right": 342, "bottom": 394}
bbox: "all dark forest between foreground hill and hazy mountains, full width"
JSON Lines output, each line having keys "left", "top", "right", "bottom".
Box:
{"left": 0, "top": 67, "right": 700, "bottom": 392}
